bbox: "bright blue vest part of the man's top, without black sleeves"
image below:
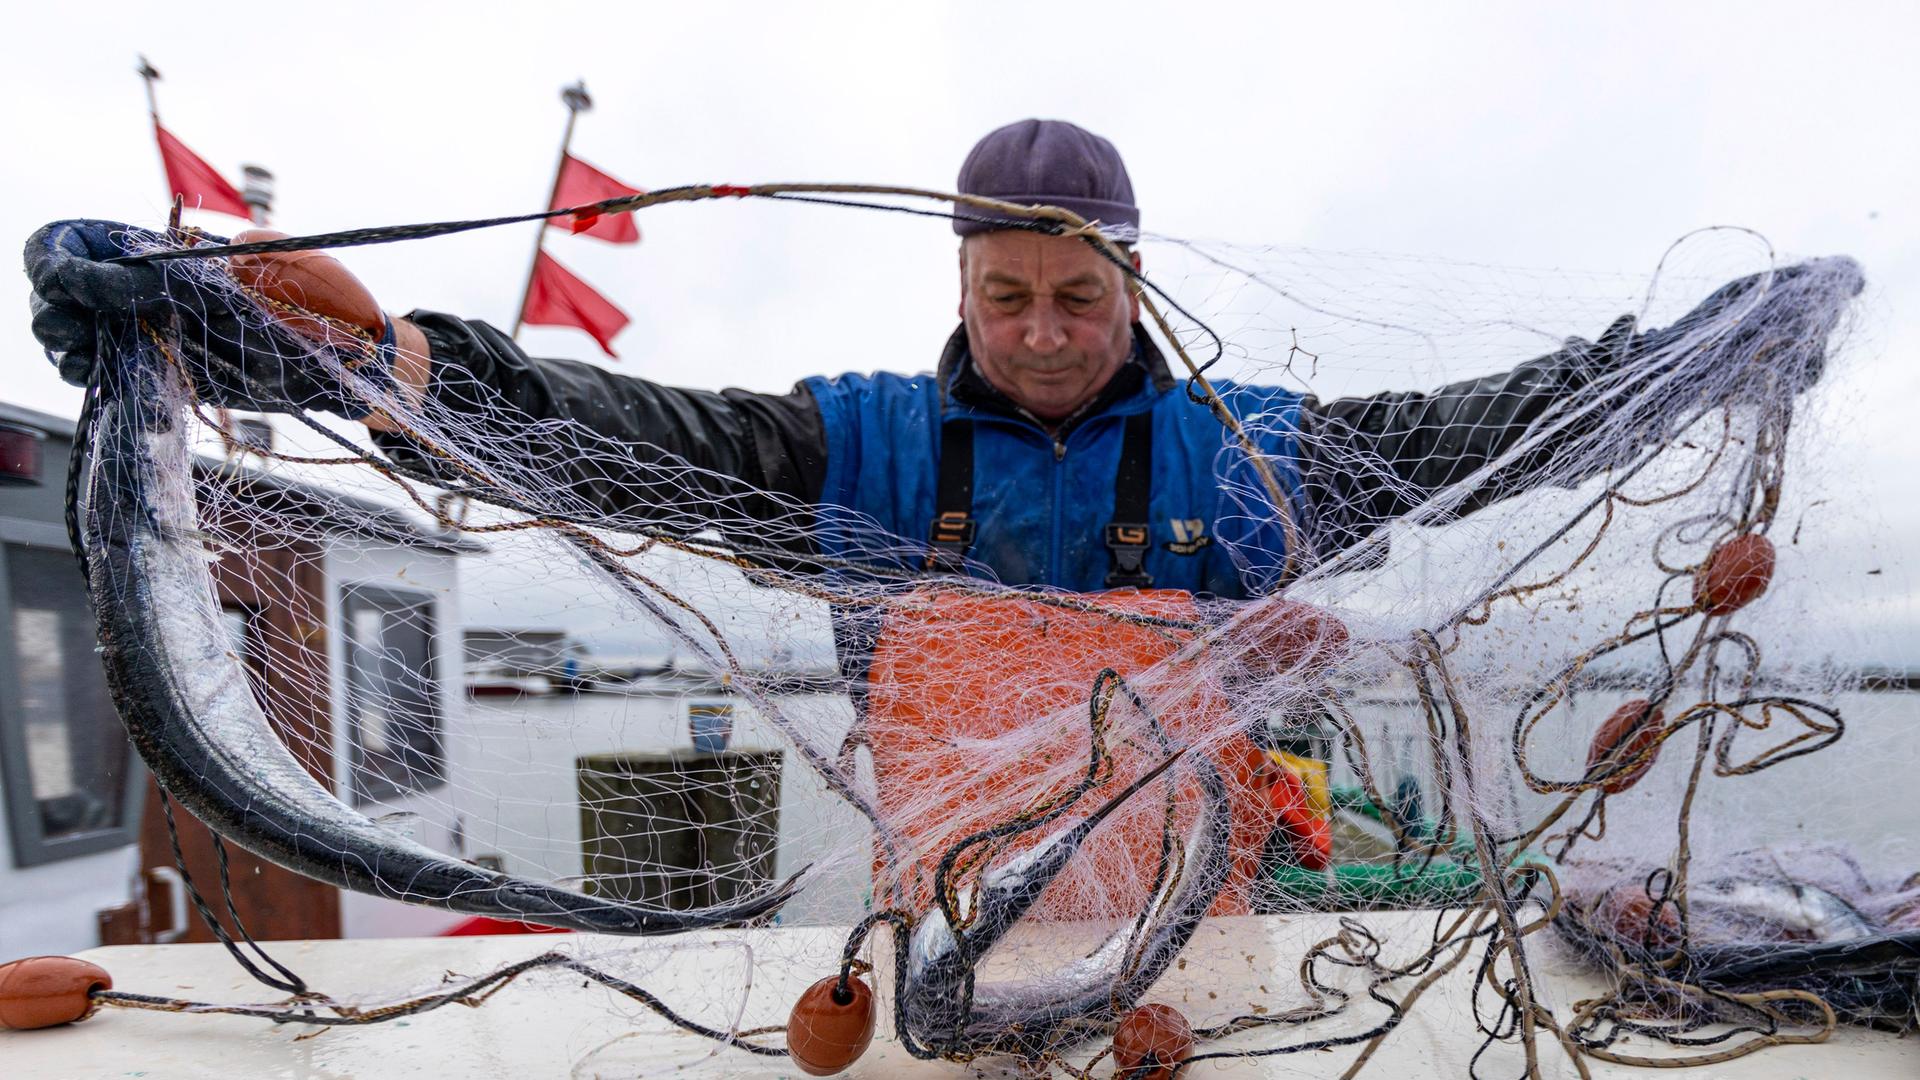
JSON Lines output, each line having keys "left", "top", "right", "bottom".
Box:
{"left": 803, "top": 322, "right": 1300, "bottom": 598}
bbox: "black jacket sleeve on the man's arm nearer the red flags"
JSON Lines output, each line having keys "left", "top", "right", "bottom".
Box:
{"left": 374, "top": 311, "right": 826, "bottom": 550}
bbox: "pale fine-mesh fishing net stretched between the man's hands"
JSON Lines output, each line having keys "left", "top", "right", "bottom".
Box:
{"left": 56, "top": 188, "right": 1920, "bottom": 1074}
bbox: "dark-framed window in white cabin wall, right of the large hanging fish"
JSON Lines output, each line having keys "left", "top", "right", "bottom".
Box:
{"left": 340, "top": 586, "right": 447, "bottom": 803}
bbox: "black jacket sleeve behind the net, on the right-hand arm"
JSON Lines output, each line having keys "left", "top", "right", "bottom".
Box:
{"left": 1300, "top": 317, "right": 1636, "bottom": 557}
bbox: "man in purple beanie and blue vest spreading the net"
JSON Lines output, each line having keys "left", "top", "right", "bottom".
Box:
{"left": 27, "top": 119, "right": 1827, "bottom": 909}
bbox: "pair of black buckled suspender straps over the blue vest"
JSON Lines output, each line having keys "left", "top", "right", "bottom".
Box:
{"left": 925, "top": 413, "right": 1154, "bottom": 588}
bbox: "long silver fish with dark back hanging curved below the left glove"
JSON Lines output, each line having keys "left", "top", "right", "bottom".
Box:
{"left": 79, "top": 342, "right": 797, "bottom": 934}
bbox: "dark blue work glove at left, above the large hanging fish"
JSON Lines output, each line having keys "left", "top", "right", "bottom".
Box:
{"left": 25, "top": 221, "right": 365, "bottom": 417}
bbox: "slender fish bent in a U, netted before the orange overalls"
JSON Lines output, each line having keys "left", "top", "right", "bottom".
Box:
{"left": 900, "top": 737, "right": 1231, "bottom": 1057}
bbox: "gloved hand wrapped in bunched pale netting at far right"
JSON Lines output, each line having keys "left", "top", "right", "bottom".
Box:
{"left": 1640, "top": 256, "right": 1866, "bottom": 396}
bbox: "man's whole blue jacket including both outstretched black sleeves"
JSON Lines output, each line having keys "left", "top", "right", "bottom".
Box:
{"left": 397, "top": 311, "right": 1638, "bottom": 598}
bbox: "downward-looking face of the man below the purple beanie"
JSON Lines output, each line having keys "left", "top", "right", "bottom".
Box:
{"left": 960, "top": 231, "right": 1140, "bottom": 421}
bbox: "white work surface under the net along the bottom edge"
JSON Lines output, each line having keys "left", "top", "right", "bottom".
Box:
{"left": 0, "top": 913, "right": 1920, "bottom": 1080}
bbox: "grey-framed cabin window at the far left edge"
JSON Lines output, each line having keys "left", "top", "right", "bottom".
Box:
{"left": 0, "top": 542, "right": 136, "bottom": 867}
